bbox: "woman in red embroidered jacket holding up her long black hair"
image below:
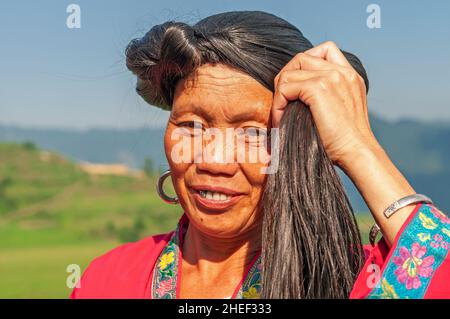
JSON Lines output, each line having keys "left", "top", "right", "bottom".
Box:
{"left": 71, "top": 12, "right": 450, "bottom": 298}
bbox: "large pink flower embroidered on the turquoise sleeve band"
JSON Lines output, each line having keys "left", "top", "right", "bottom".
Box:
{"left": 393, "top": 243, "right": 434, "bottom": 290}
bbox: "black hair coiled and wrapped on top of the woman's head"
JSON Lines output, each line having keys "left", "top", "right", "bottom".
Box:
{"left": 126, "top": 11, "right": 369, "bottom": 110}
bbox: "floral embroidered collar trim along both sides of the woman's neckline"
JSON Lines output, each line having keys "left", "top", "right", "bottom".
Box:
{"left": 151, "top": 218, "right": 261, "bottom": 299}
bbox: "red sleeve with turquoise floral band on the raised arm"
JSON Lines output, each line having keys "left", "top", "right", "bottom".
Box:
{"left": 350, "top": 204, "right": 450, "bottom": 299}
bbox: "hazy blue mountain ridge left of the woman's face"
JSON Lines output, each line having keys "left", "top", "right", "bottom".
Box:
{"left": 0, "top": 126, "right": 167, "bottom": 168}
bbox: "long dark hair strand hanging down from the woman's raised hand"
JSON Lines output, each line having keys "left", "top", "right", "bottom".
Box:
{"left": 262, "top": 101, "right": 363, "bottom": 298}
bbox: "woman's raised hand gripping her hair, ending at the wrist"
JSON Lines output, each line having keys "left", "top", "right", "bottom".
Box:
{"left": 272, "top": 42, "right": 377, "bottom": 166}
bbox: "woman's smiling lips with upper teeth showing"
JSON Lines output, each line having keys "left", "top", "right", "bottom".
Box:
{"left": 191, "top": 185, "right": 244, "bottom": 211}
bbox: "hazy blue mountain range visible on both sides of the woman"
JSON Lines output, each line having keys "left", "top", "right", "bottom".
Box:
{"left": 0, "top": 116, "right": 450, "bottom": 213}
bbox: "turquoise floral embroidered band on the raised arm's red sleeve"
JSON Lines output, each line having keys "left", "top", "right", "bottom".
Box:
{"left": 367, "top": 204, "right": 450, "bottom": 299}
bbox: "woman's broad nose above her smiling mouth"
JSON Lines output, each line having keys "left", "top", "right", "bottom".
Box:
{"left": 194, "top": 132, "right": 239, "bottom": 176}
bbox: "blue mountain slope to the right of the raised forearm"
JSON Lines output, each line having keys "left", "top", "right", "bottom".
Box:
{"left": 344, "top": 116, "right": 450, "bottom": 214}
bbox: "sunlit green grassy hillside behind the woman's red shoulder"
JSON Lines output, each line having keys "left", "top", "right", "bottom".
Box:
{"left": 0, "top": 143, "right": 371, "bottom": 298}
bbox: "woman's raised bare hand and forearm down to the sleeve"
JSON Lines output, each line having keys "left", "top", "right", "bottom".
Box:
{"left": 272, "top": 42, "right": 415, "bottom": 244}
